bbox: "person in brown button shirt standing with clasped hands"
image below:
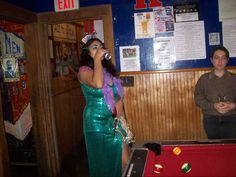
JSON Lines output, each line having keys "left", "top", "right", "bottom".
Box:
{"left": 194, "top": 46, "right": 236, "bottom": 139}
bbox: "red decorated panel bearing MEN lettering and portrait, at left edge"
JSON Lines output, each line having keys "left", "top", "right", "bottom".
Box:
{"left": 0, "top": 20, "right": 32, "bottom": 140}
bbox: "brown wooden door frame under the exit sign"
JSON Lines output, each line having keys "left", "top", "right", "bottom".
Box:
{"left": 25, "top": 4, "right": 114, "bottom": 177}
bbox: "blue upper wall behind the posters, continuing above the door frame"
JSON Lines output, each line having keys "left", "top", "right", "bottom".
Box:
{"left": 6, "top": 0, "right": 236, "bottom": 70}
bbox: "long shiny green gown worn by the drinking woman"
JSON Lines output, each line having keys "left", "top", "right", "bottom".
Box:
{"left": 81, "top": 84, "right": 122, "bottom": 177}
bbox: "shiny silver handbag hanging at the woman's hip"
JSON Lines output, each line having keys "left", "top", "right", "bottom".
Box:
{"left": 114, "top": 116, "right": 135, "bottom": 145}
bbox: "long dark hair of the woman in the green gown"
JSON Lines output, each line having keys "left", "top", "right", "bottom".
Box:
{"left": 79, "top": 38, "right": 118, "bottom": 77}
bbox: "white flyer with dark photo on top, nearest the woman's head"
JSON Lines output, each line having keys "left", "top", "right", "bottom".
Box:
{"left": 120, "top": 46, "right": 140, "bottom": 71}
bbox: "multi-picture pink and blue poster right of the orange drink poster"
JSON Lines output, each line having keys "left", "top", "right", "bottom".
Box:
{"left": 153, "top": 6, "right": 174, "bottom": 33}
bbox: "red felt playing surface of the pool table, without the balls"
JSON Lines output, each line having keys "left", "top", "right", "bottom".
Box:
{"left": 143, "top": 144, "right": 236, "bottom": 177}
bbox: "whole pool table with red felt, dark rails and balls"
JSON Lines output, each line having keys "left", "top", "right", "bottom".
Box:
{"left": 122, "top": 140, "right": 236, "bottom": 177}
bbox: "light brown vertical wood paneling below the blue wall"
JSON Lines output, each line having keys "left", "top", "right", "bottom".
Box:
{"left": 121, "top": 68, "right": 236, "bottom": 142}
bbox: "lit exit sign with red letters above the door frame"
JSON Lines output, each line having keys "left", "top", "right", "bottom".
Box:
{"left": 54, "top": 0, "right": 79, "bottom": 12}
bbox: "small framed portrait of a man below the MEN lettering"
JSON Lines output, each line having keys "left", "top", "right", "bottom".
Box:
{"left": 1, "top": 56, "right": 20, "bottom": 82}
